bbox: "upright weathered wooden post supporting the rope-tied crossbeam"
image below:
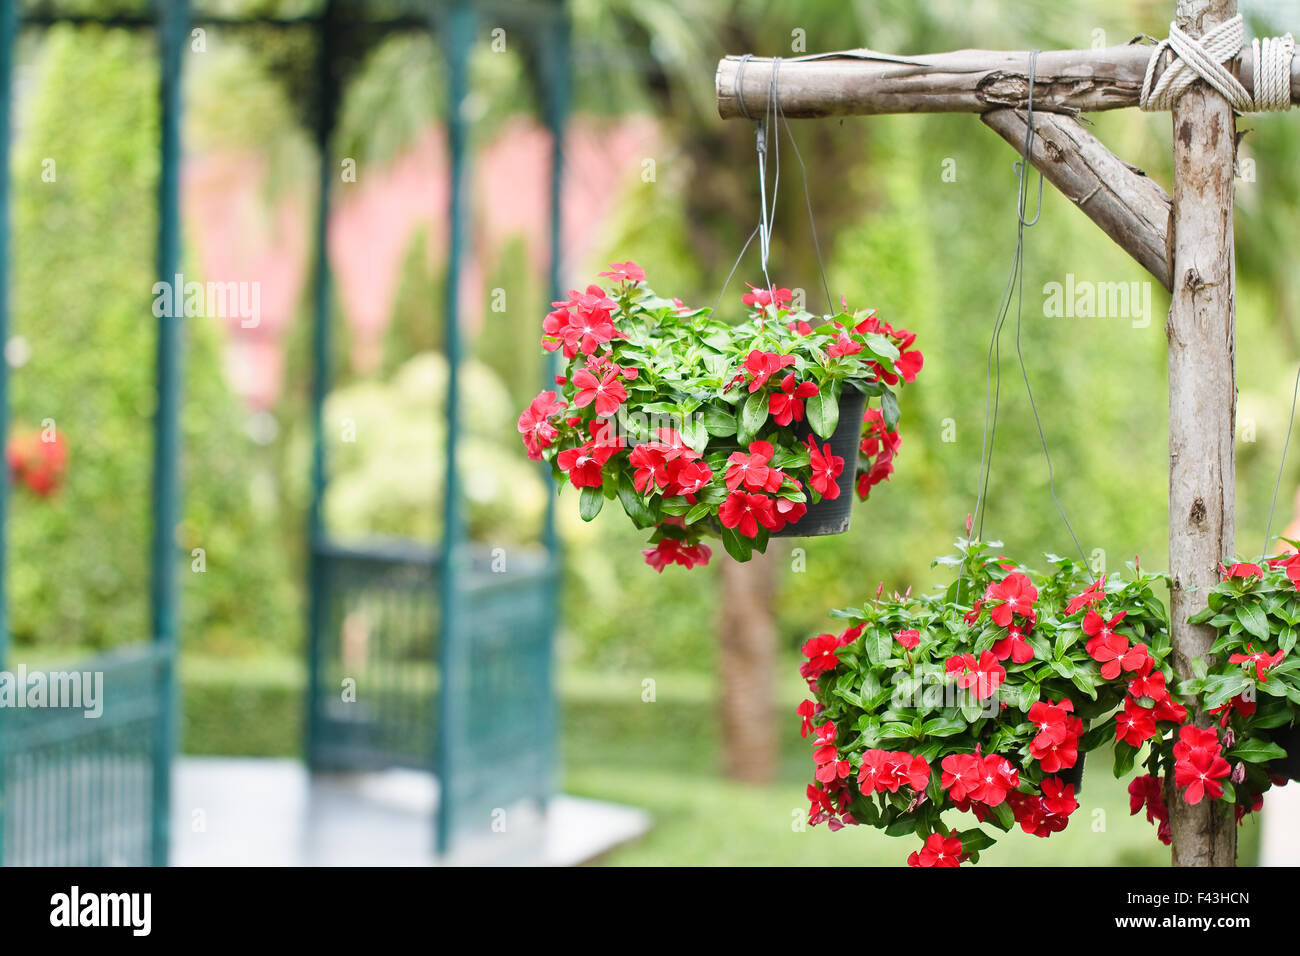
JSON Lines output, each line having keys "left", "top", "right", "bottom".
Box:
{"left": 1165, "top": 0, "right": 1236, "bottom": 866}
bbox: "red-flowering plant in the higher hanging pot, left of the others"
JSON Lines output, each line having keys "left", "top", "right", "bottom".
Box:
{"left": 519, "top": 263, "right": 923, "bottom": 571}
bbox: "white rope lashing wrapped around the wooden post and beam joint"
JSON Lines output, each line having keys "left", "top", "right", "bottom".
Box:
{"left": 1139, "top": 13, "right": 1295, "bottom": 113}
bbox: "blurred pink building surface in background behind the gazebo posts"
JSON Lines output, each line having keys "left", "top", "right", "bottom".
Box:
{"left": 183, "top": 118, "right": 655, "bottom": 408}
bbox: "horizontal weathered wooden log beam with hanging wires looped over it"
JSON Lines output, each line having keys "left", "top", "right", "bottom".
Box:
{"left": 716, "top": 43, "right": 1300, "bottom": 120}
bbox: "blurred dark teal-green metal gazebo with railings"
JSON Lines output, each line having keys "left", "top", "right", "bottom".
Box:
{"left": 0, "top": 0, "right": 569, "bottom": 865}
